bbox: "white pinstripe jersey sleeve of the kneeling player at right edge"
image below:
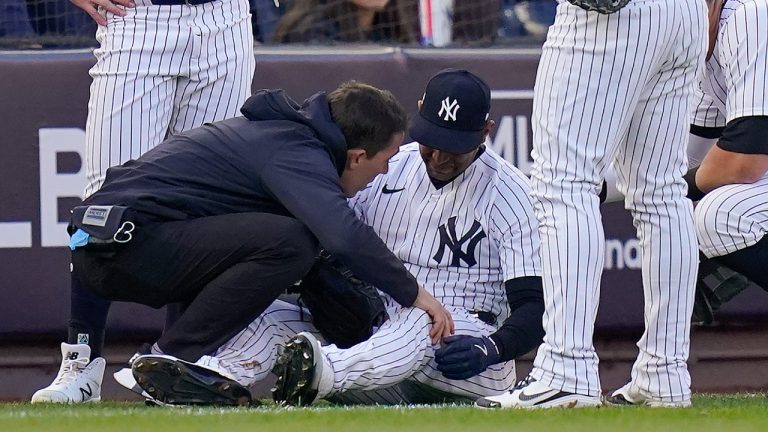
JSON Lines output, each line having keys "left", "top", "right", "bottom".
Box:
{"left": 715, "top": 0, "right": 768, "bottom": 122}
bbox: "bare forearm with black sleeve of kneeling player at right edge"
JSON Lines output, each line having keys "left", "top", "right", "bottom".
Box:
{"left": 685, "top": 116, "right": 768, "bottom": 200}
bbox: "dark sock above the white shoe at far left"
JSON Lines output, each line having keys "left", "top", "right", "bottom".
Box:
{"left": 67, "top": 273, "right": 112, "bottom": 359}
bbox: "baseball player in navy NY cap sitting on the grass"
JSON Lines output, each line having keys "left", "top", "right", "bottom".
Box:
{"left": 127, "top": 69, "right": 544, "bottom": 405}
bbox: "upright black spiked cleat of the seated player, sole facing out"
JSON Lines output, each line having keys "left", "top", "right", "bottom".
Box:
{"left": 272, "top": 333, "right": 324, "bottom": 406}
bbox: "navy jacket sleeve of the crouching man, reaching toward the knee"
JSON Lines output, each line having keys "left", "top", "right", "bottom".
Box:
{"left": 261, "top": 143, "right": 418, "bottom": 307}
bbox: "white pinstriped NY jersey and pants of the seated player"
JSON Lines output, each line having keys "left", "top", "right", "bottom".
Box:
{"left": 210, "top": 143, "right": 540, "bottom": 403}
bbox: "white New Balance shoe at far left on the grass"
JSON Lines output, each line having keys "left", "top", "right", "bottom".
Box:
{"left": 32, "top": 342, "right": 107, "bottom": 403}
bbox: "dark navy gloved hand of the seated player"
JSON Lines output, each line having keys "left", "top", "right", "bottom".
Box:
{"left": 435, "top": 335, "right": 500, "bottom": 380}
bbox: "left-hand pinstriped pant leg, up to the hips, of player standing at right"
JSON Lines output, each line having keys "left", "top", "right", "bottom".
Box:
{"left": 531, "top": 0, "right": 704, "bottom": 396}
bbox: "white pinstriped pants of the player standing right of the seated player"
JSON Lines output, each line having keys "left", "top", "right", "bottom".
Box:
{"left": 531, "top": 0, "right": 707, "bottom": 402}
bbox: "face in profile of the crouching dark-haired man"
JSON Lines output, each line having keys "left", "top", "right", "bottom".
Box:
{"left": 339, "top": 132, "right": 405, "bottom": 198}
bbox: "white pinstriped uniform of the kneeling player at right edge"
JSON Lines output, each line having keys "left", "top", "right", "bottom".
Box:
{"left": 693, "top": 0, "right": 768, "bottom": 258}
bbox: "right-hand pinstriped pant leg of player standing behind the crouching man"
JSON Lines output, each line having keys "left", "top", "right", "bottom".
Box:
{"left": 170, "top": 0, "right": 256, "bottom": 134}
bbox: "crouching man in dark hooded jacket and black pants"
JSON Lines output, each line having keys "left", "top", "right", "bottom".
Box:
{"left": 72, "top": 82, "right": 452, "bottom": 361}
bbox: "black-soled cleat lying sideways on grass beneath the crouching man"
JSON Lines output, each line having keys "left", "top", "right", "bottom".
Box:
{"left": 131, "top": 355, "right": 258, "bottom": 406}
